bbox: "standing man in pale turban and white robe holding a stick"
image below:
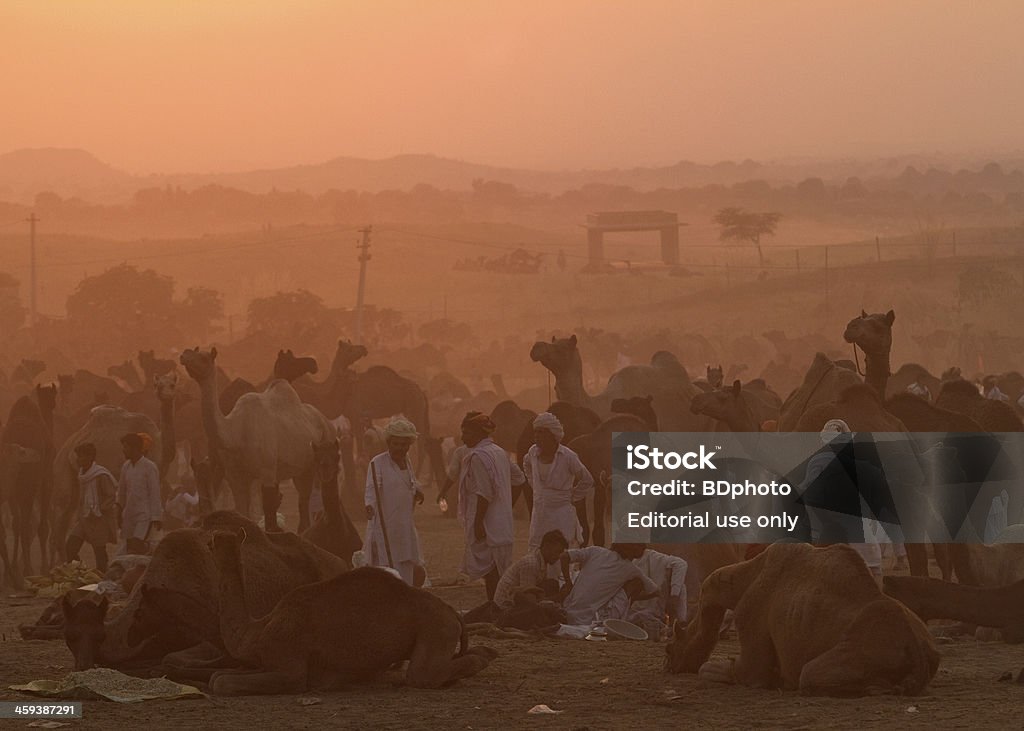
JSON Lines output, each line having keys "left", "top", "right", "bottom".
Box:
{"left": 364, "top": 417, "right": 423, "bottom": 586}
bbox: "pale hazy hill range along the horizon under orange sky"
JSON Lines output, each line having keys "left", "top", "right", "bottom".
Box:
{"left": 0, "top": 147, "right": 1022, "bottom": 204}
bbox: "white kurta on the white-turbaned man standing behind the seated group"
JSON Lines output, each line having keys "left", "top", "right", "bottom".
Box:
{"left": 523, "top": 444, "right": 594, "bottom": 549}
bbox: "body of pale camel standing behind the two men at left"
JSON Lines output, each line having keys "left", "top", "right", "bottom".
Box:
{"left": 50, "top": 406, "right": 163, "bottom": 556}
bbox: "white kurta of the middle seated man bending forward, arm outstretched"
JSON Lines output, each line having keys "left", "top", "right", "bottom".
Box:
{"left": 563, "top": 546, "right": 657, "bottom": 625}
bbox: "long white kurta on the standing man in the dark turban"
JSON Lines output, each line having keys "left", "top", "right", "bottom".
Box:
{"left": 459, "top": 438, "right": 515, "bottom": 579}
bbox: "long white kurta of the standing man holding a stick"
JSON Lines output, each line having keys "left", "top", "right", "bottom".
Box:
{"left": 364, "top": 452, "right": 421, "bottom": 584}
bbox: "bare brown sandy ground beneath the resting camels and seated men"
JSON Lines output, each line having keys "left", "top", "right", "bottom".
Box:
{"left": 0, "top": 506, "right": 1024, "bottom": 729}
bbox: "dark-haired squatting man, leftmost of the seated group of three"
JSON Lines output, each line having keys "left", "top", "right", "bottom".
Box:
{"left": 465, "top": 530, "right": 568, "bottom": 624}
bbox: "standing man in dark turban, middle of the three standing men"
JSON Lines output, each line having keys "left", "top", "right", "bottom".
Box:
{"left": 459, "top": 412, "right": 515, "bottom": 601}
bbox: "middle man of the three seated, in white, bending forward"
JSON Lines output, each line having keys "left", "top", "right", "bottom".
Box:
{"left": 561, "top": 544, "right": 658, "bottom": 626}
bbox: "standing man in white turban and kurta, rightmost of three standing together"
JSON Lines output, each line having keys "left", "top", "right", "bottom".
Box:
{"left": 523, "top": 412, "right": 594, "bottom": 549}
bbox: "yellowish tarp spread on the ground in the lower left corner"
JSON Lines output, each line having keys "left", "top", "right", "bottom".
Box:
{"left": 10, "top": 668, "right": 206, "bottom": 703}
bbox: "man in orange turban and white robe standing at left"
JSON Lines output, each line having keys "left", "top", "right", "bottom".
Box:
{"left": 117, "top": 434, "right": 164, "bottom": 555}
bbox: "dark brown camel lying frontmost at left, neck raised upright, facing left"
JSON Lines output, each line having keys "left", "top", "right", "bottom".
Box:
{"left": 210, "top": 532, "right": 496, "bottom": 695}
